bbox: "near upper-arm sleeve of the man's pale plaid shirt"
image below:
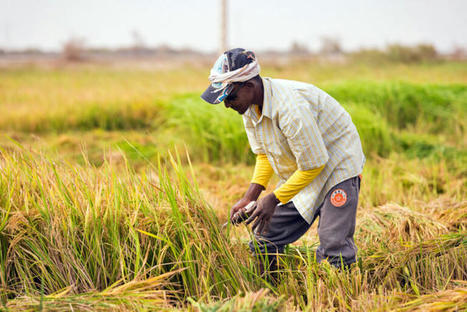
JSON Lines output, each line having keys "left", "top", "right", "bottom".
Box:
{"left": 279, "top": 94, "right": 329, "bottom": 171}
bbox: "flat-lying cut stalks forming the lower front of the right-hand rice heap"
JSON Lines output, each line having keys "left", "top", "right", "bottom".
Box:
{"left": 362, "top": 233, "right": 467, "bottom": 294}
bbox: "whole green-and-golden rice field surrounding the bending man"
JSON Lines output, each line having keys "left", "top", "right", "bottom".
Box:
{"left": 0, "top": 62, "right": 467, "bottom": 311}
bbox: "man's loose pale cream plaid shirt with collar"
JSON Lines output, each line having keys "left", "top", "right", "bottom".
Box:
{"left": 243, "top": 78, "right": 365, "bottom": 223}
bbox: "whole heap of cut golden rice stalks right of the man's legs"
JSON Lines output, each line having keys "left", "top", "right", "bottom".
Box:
{"left": 356, "top": 204, "right": 467, "bottom": 294}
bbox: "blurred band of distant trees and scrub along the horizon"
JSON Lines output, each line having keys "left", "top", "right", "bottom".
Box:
{"left": 0, "top": 38, "right": 467, "bottom": 63}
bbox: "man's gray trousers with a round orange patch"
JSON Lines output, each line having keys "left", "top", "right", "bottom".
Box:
{"left": 249, "top": 177, "right": 360, "bottom": 267}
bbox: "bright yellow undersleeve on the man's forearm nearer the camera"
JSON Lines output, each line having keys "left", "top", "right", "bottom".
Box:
{"left": 273, "top": 165, "right": 324, "bottom": 204}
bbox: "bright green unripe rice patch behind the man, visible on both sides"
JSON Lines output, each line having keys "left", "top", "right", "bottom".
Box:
{"left": 168, "top": 81, "right": 467, "bottom": 161}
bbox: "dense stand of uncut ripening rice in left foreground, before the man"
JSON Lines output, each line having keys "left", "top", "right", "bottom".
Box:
{"left": 0, "top": 146, "right": 270, "bottom": 308}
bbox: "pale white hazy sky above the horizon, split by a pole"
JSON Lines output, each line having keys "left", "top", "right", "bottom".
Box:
{"left": 0, "top": 0, "right": 467, "bottom": 51}
